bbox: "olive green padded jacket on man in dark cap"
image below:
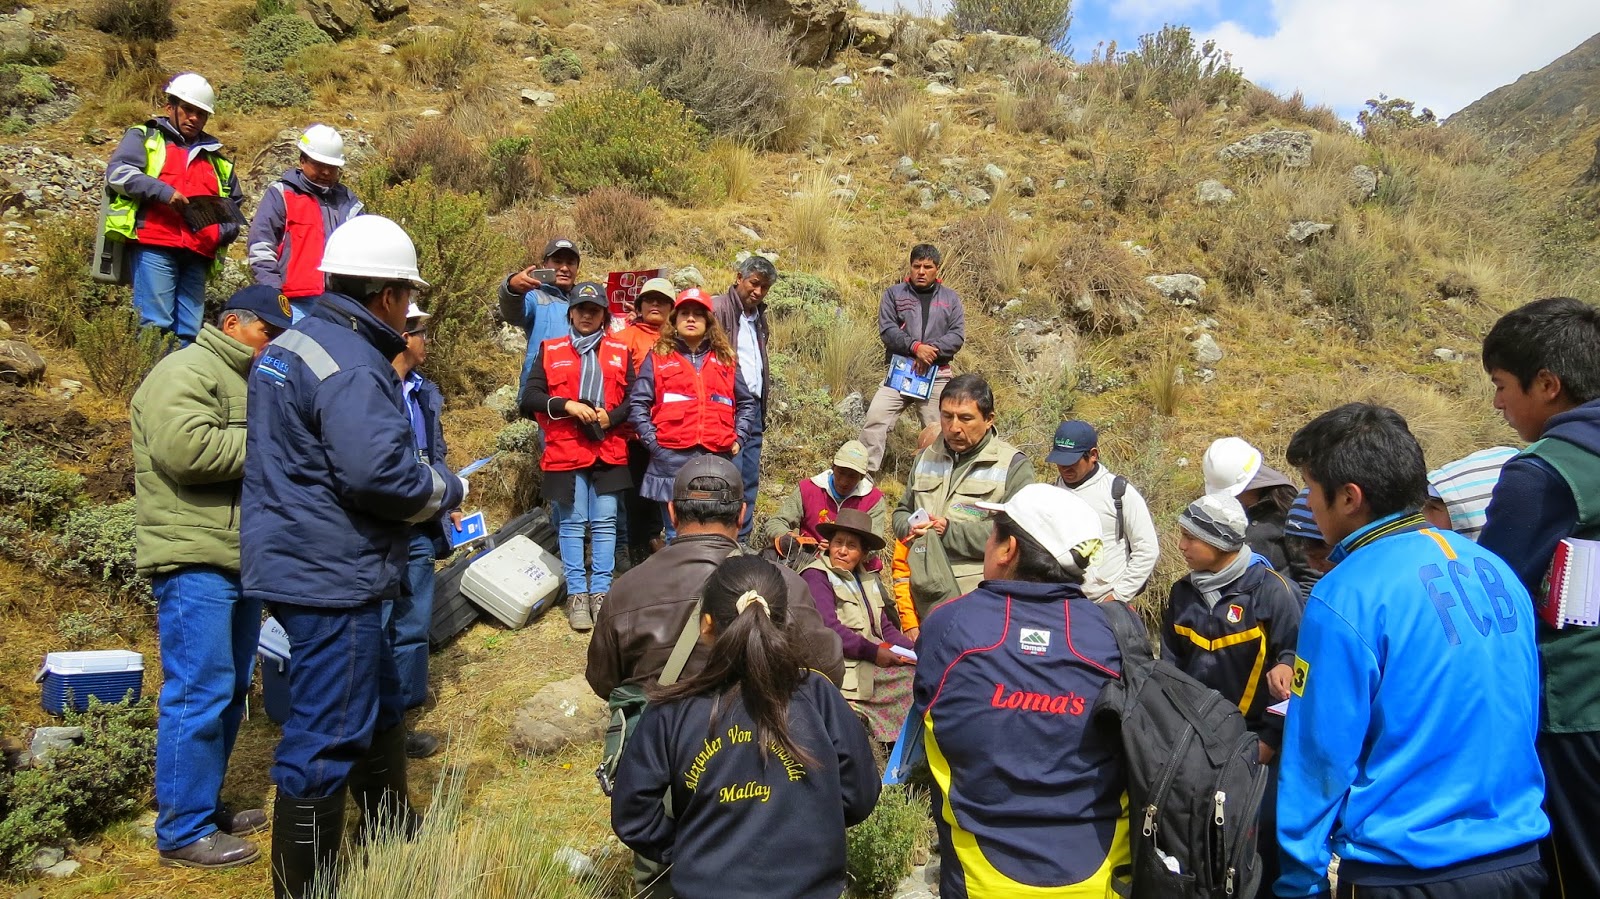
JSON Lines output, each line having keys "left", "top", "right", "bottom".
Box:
{"left": 130, "top": 325, "right": 254, "bottom": 576}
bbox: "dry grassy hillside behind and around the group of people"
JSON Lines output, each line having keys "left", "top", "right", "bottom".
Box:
{"left": 0, "top": 0, "right": 1600, "bottom": 896}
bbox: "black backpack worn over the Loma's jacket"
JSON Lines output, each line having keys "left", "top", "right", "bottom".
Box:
{"left": 1093, "top": 600, "right": 1267, "bottom": 899}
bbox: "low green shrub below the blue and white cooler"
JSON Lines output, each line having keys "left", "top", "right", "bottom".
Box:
{"left": 0, "top": 697, "right": 155, "bottom": 870}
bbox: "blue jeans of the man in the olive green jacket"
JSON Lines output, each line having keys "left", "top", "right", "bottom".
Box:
{"left": 152, "top": 565, "right": 261, "bottom": 849}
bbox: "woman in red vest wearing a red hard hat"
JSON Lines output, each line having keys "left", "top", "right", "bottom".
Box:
{"left": 627, "top": 288, "right": 757, "bottom": 537}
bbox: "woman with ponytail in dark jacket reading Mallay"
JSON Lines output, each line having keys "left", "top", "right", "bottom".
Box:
{"left": 611, "top": 555, "right": 878, "bottom": 899}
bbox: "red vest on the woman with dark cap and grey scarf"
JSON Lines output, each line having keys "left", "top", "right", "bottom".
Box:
{"left": 534, "top": 338, "right": 629, "bottom": 472}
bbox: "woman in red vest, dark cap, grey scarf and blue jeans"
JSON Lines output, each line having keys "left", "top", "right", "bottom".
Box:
{"left": 520, "top": 282, "right": 634, "bottom": 630}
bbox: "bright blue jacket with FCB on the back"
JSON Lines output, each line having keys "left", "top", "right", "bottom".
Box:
{"left": 1275, "top": 515, "right": 1549, "bottom": 897}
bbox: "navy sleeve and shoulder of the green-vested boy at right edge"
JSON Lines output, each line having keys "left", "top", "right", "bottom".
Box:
{"left": 1478, "top": 400, "right": 1600, "bottom": 595}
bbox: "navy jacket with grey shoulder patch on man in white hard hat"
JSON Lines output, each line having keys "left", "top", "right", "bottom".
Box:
{"left": 240, "top": 293, "right": 461, "bottom": 608}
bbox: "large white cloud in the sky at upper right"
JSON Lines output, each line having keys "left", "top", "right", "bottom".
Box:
{"left": 1205, "top": 0, "right": 1600, "bottom": 117}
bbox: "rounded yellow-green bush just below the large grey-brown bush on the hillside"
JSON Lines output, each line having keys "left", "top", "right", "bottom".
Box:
{"left": 538, "top": 88, "right": 710, "bottom": 200}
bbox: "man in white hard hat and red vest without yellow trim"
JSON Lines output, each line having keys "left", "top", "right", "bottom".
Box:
{"left": 246, "top": 125, "right": 362, "bottom": 322}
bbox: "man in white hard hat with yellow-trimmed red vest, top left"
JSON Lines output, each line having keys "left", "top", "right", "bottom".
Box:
{"left": 104, "top": 72, "right": 245, "bottom": 344}
